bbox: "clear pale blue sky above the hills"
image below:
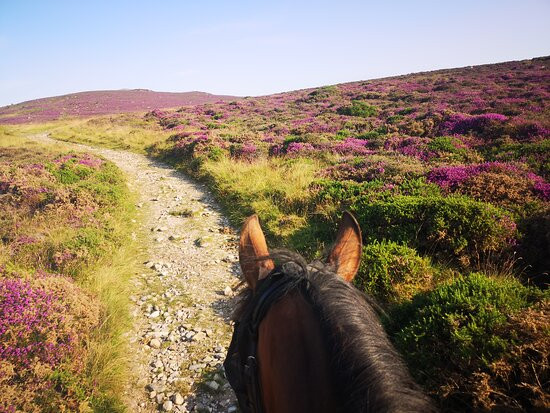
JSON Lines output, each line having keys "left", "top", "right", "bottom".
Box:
{"left": 0, "top": 0, "right": 550, "bottom": 105}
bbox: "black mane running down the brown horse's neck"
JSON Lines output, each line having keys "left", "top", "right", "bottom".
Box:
{"left": 234, "top": 250, "right": 436, "bottom": 413}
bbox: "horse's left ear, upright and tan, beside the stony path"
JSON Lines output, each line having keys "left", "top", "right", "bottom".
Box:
{"left": 239, "top": 215, "right": 275, "bottom": 290}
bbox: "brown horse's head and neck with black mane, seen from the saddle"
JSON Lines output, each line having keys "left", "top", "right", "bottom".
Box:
{"left": 224, "top": 212, "right": 436, "bottom": 413}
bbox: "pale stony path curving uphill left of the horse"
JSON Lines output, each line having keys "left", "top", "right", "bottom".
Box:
{"left": 33, "top": 135, "right": 240, "bottom": 412}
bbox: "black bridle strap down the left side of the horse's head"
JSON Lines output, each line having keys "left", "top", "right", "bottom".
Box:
{"left": 223, "top": 267, "right": 309, "bottom": 413}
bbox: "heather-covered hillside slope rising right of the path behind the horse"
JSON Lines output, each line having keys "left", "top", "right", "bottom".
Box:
{"left": 140, "top": 57, "right": 550, "bottom": 412}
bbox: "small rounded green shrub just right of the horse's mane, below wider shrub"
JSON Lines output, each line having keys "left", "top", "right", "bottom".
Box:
{"left": 354, "top": 241, "right": 434, "bottom": 301}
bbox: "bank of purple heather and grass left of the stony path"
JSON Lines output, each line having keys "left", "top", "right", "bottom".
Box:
{"left": 0, "top": 133, "right": 136, "bottom": 412}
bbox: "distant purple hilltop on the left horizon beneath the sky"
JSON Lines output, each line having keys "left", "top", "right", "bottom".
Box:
{"left": 0, "top": 89, "right": 239, "bottom": 124}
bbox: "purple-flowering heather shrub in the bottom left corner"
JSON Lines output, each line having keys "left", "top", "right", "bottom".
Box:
{"left": 0, "top": 275, "right": 100, "bottom": 411}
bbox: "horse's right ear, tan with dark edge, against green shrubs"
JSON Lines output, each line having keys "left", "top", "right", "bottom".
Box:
{"left": 328, "top": 211, "right": 363, "bottom": 281}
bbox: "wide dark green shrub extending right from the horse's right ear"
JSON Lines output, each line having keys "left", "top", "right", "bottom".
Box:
{"left": 349, "top": 195, "right": 516, "bottom": 265}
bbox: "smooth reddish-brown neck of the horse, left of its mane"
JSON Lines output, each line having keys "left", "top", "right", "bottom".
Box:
{"left": 258, "top": 292, "right": 339, "bottom": 413}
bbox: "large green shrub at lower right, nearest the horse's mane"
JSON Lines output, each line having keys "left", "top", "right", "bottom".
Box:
{"left": 386, "top": 273, "right": 548, "bottom": 374}
